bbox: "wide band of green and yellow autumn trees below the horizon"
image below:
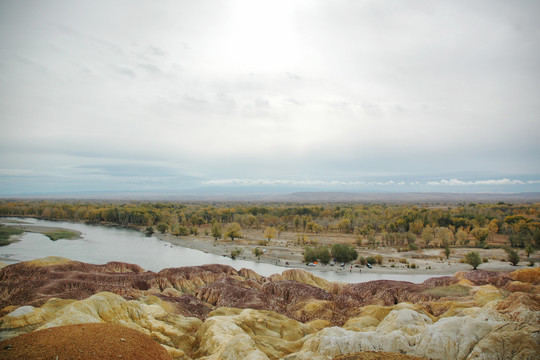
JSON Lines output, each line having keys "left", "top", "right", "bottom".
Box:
{"left": 0, "top": 200, "right": 540, "bottom": 249}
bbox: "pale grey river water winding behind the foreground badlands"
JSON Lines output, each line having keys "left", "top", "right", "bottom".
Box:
{"left": 0, "top": 218, "right": 446, "bottom": 283}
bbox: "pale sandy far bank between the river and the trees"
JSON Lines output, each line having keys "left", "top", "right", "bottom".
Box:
{"left": 155, "top": 229, "right": 540, "bottom": 275}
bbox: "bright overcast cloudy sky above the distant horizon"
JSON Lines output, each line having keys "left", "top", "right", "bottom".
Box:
{"left": 0, "top": 0, "right": 540, "bottom": 196}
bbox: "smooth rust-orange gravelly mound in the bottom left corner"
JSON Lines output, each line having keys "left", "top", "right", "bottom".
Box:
{"left": 0, "top": 323, "right": 171, "bottom": 360}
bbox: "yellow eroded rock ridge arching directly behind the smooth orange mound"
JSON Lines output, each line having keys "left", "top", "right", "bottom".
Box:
{"left": 0, "top": 292, "right": 202, "bottom": 358}
